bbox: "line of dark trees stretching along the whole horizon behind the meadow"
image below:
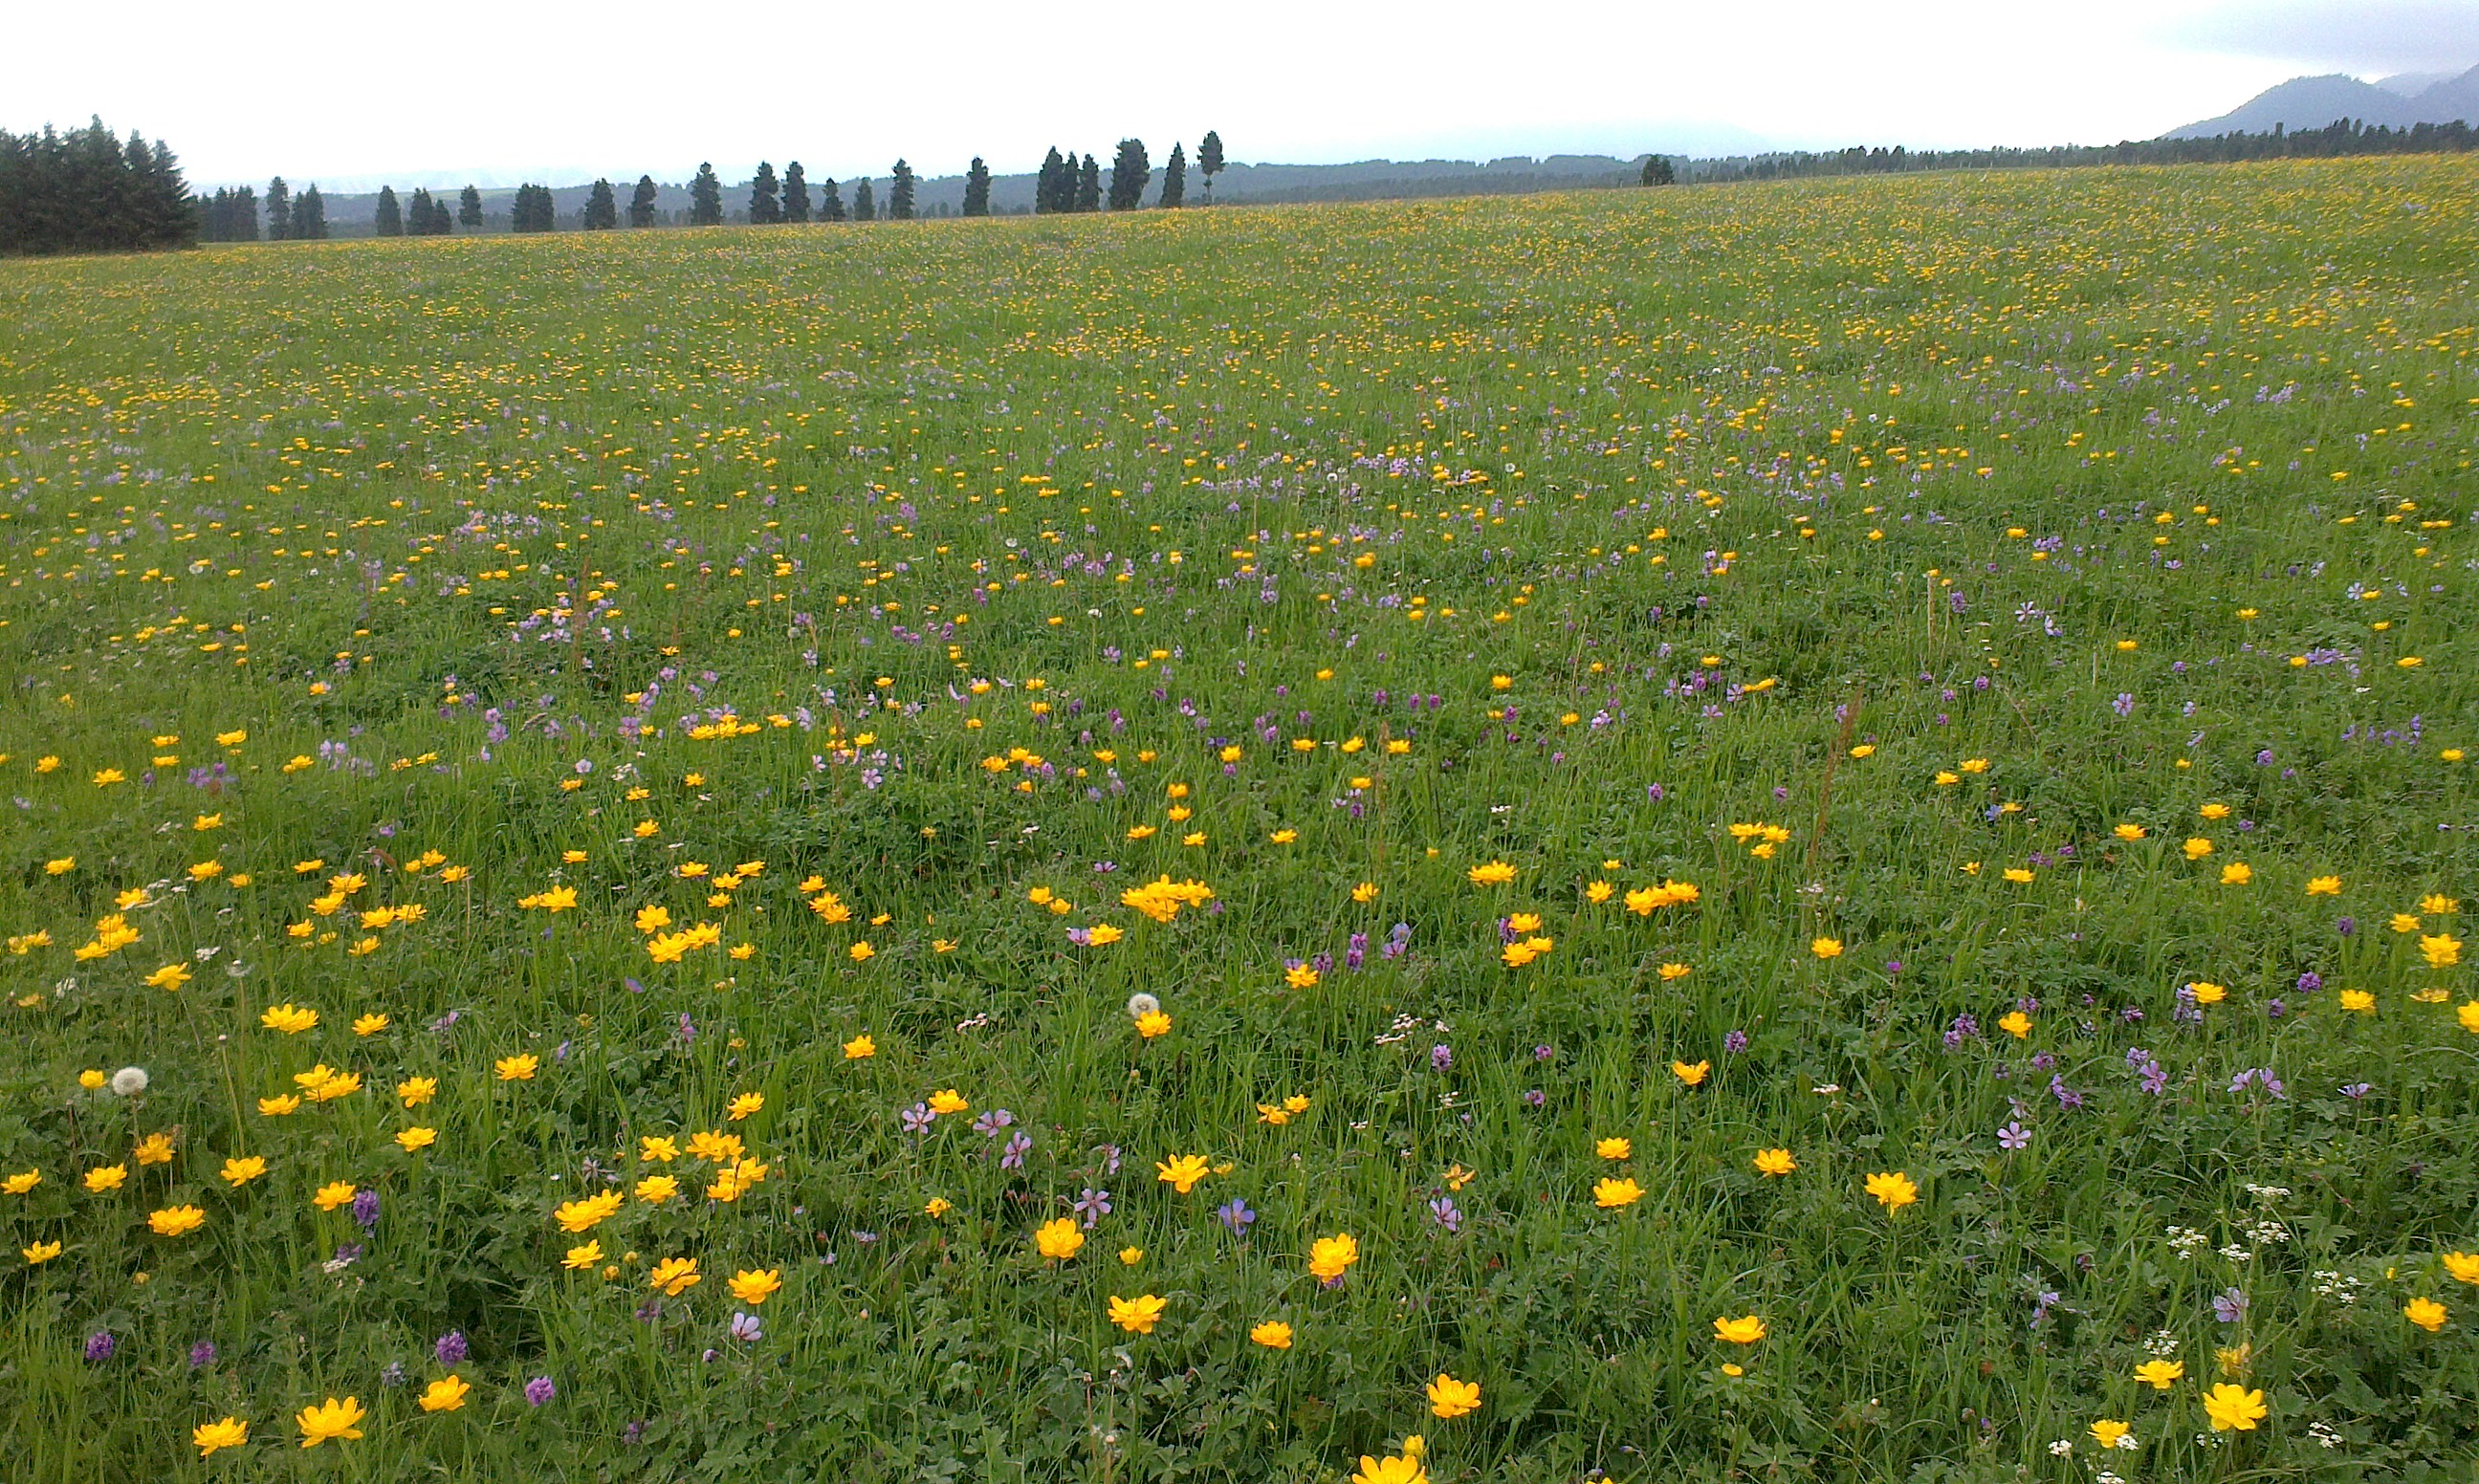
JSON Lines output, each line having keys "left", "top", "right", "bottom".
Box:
{"left": 0, "top": 117, "right": 2479, "bottom": 255}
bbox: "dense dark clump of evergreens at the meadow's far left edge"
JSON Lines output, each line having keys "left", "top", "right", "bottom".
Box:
{"left": 0, "top": 119, "right": 204, "bottom": 252}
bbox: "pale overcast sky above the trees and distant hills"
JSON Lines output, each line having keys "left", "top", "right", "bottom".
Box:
{"left": 0, "top": 0, "right": 2479, "bottom": 188}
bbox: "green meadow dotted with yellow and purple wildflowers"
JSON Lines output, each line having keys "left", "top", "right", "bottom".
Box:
{"left": 0, "top": 159, "right": 2479, "bottom": 1484}
